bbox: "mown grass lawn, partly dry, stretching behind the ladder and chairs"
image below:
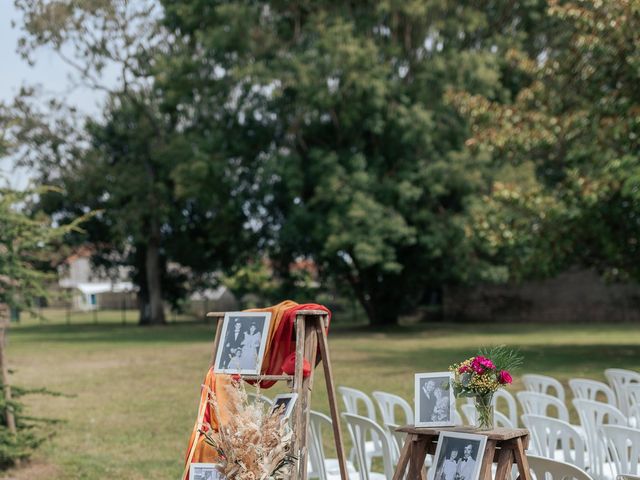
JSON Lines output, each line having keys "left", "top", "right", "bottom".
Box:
{"left": 0, "top": 312, "right": 640, "bottom": 480}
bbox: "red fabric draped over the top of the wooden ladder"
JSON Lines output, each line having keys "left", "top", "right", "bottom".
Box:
{"left": 250, "top": 303, "right": 331, "bottom": 388}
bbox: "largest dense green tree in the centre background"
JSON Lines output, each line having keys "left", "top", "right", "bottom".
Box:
{"left": 159, "top": 0, "right": 543, "bottom": 324}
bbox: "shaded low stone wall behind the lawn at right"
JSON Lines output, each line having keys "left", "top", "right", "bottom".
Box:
{"left": 443, "top": 270, "right": 640, "bottom": 323}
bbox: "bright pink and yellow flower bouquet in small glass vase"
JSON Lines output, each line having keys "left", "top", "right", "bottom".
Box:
{"left": 449, "top": 346, "right": 522, "bottom": 430}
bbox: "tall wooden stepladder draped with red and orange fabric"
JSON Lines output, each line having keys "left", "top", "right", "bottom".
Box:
{"left": 207, "top": 310, "right": 349, "bottom": 480}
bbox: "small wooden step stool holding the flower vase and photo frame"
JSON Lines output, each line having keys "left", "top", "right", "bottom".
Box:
{"left": 393, "top": 425, "right": 531, "bottom": 480}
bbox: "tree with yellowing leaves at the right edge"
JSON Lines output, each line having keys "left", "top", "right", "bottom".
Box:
{"left": 451, "top": 0, "right": 640, "bottom": 281}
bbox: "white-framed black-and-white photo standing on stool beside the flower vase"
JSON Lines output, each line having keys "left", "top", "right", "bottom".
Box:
{"left": 415, "top": 372, "right": 455, "bottom": 427}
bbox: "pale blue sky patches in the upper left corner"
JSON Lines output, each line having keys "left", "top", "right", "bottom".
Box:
{"left": 0, "top": 0, "right": 111, "bottom": 188}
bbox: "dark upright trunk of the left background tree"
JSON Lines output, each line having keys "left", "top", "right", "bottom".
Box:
{"left": 140, "top": 234, "right": 165, "bottom": 325}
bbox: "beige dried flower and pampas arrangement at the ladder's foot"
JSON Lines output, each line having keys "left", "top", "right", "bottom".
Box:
{"left": 201, "top": 380, "right": 296, "bottom": 480}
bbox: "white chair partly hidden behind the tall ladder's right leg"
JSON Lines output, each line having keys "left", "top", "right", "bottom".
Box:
{"left": 307, "top": 410, "right": 360, "bottom": 480}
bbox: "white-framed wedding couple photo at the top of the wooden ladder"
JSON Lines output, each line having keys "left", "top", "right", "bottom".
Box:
{"left": 213, "top": 312, "right": 271, "bottom": 375}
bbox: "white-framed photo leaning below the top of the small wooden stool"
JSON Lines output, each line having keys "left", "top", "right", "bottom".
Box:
{"left": 429, "top": 432, "right": 487, "bottom": 480}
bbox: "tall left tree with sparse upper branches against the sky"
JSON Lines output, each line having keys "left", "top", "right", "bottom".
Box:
{"left": 16, "top": 0, "right": 246, "bottom": 324}
